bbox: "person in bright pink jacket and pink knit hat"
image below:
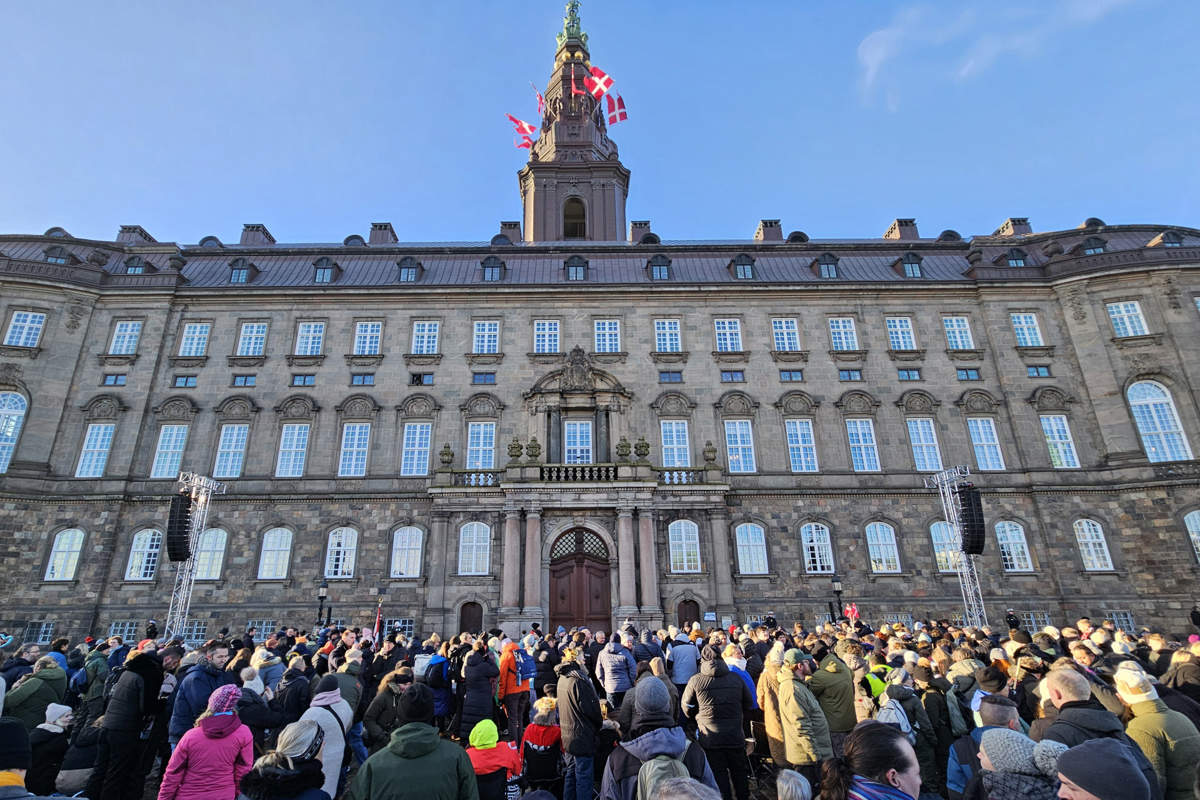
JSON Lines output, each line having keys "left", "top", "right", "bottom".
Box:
{"left": 158, "top": 685, "right": 254, "bottom": 800}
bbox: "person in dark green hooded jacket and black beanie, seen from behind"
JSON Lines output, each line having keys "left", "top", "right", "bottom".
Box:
{"left": 346, "top": 684, "right": 479, "bottom": 800}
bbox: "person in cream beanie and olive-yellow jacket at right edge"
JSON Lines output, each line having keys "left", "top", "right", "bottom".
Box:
{"left": 1115, "top": 669, "right": 1200, "bottom": 800}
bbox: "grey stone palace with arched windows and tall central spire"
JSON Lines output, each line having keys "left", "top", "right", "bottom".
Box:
{"left": 0, "top": 10, "right": 1200, "bottom": 640}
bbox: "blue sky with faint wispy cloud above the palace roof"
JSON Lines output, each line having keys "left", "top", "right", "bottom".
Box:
{"left": 0, "top": 0, "right": 1200, "bottom": 243}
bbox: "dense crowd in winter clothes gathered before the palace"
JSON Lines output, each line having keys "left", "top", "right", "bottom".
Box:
{"left": 0, "top": 613, "right": 1200, "bottom": 800}
